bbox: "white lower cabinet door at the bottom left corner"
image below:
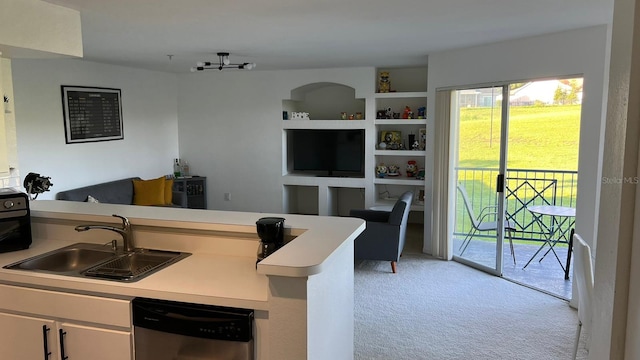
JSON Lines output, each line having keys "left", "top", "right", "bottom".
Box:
{"left": 0, "top": 313, "right": 58, "bottom": 360}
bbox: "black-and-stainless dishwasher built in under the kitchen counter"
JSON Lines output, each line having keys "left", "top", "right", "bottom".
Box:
{"left": 132, "top": 298, "right": 254, "bottom": 360}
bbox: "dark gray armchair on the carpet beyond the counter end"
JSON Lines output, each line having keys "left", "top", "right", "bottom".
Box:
{"left": 350, "top": 191, "right": 413, "bottom": 273}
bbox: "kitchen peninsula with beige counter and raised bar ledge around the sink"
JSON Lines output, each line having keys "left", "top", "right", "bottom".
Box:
{"left": 0, "top": 200, "right": 365, "bottom": 360}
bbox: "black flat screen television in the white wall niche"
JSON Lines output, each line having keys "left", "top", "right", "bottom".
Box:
{"left": 289, "top": 129, "right": 364, "bottom": 177}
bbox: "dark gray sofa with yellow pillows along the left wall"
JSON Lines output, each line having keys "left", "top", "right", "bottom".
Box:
{"left": 56, "top": 177, "right": 187, "bottom": 207}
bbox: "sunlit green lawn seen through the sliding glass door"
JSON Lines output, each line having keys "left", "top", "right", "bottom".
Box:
{"left": 456, "top": 105, "right": 580, "bottom": 240}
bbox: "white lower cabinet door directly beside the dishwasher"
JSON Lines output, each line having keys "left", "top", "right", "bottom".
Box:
{"left": 58, "top": 323, "right": 132, "bottom": 360}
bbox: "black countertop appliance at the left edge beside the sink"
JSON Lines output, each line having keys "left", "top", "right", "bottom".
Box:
{"left": 0, "top": 189, "right": 31, "bottom": 253}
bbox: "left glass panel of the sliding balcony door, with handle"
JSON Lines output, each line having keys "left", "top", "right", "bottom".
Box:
{"left": 450, "top": 86, "right": 509, "bottom": 275}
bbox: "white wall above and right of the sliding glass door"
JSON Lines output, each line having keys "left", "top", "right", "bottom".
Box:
{"left": 427, "top": 25, "right": 608, "bottom": 258}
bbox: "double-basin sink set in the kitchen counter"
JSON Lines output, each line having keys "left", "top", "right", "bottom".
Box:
{"left": 4, "top": 243, "right": 191, "bottom": 282}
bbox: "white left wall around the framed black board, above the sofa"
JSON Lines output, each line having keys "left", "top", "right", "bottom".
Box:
{"left": 12, "top": 59, "right": 178, "bottom": 199}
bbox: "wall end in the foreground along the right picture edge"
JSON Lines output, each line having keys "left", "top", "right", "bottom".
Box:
{"left": 589, "top": 0, "right": 640, "bottom": 360}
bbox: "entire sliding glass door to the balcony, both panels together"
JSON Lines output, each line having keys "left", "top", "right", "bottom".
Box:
{"left": 450, "top": 77, "right": 583, "bottom": 292}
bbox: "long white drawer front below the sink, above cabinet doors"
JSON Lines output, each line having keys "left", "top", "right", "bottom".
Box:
{"left": 0, "top": 284, "right": 131, "bottom": 329}
